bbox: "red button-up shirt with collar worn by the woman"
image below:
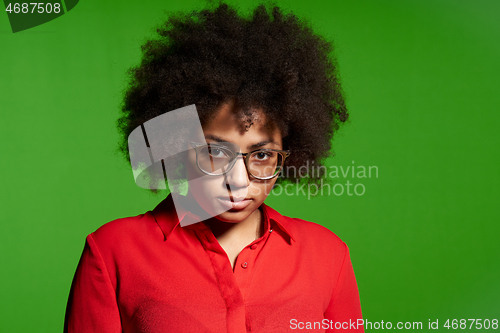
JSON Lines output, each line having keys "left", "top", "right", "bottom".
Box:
{"left": 65, "top": 196, "right": 363, "bottom": 333}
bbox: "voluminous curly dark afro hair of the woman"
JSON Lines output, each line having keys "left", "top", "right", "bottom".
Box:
{"left": 118, "top": 3, "right": 348, "bottom": 192}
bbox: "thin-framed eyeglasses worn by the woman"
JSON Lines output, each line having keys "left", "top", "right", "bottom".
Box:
{"left": 190, "top": 142, "right": 290, "bottom": 180}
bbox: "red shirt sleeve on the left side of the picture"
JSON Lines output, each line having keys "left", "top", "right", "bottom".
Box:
{"left": 64, "top": 234, "right": 122, "bottom": 333}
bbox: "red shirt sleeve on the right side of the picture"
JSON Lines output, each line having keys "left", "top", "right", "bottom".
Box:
{"left": 325, "top": 244, "right": 364, "bottom": 332}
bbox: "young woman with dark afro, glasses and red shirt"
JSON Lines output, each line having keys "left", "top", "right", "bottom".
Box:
{"left": 65, "top": 4, "right": 363, "bottom": 332}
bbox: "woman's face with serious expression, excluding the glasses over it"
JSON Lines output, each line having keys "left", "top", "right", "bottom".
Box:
{"left": 187, "top": 103, "right": 283, "bottom": 223}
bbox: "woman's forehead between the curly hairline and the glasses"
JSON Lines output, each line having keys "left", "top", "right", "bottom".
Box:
{"left": 203, "top": 103, "right": 282, "bottom": 148}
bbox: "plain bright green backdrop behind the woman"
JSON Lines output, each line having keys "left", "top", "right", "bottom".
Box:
{"left": 0, "top": 0, "right": 500, "bottom": 332}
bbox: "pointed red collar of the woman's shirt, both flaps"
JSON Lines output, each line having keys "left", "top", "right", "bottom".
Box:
{"left": 151, "top": 194, "right": 295, "bottom": 244}
